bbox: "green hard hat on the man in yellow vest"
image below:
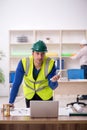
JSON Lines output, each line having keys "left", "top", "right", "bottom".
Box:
{"left": 32, "top": 40, "right": 47, "bottom": 52}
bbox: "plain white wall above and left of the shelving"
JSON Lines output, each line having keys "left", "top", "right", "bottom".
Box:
{"left": 0, "top": 0, "right": 87, "bottom": 95}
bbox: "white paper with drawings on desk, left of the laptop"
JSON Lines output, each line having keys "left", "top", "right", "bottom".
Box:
{"left": 10, "top": 108, "right": 30, "bottom": 116}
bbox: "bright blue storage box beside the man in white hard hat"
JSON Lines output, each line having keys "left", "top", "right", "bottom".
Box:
{"left": 67, "top": 69, "right": 84, "bottom": 79}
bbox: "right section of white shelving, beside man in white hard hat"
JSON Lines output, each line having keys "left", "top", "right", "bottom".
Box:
{"left": 61, "top": 30, "right": 86, "bottom": 77}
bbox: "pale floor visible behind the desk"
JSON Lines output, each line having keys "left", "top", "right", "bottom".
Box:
{"left": 0, "top": 95, "right": 87, "bottom": 108}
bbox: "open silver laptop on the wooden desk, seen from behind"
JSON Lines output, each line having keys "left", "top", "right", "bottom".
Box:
{"left": 30, "top": 100, "right": 59, "bottom": 118}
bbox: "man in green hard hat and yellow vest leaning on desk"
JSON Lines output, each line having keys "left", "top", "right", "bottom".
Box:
{"left": 9, "top": 40, "right": 59, "bottom": 107}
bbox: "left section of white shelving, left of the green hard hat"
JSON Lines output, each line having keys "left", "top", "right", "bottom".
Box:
{"left": 9, "top": 30, "right": 34, "bottom": 71}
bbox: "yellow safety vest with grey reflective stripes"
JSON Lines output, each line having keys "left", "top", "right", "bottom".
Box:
{"left": 22, "top": 56, "right": 54, "bottom": 100}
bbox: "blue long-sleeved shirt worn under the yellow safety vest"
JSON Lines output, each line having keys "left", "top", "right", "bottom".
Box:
{"left": 9, "top": 61, "right": 58, "bottom": 104}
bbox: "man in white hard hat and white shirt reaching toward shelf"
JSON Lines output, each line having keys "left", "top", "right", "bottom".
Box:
{"left": 71, "top": 39, "right": 87, "bottom": 99}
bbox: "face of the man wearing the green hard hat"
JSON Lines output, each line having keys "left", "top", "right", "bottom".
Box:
{"left": 32, "top": 51, "right": 45, "bottom": 65}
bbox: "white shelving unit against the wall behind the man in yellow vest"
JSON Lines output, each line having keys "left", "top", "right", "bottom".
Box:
{"left": 9, "top": 30, "right": 87, "bottom": 82}
